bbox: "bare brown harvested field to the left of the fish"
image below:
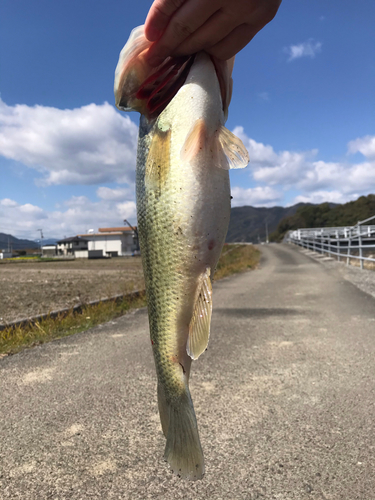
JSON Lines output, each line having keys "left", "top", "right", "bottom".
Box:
{"left": 0, "top": 257, "right": 144, "bottom": 324}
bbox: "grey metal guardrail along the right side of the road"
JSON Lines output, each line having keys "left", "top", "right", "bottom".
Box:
{"left": 285, "top": 215, "right": 375, "bottom": 269}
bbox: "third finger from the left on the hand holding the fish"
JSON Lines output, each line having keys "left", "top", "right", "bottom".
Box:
{"left": 173, "top": 11, "right": 238, "bottom": 56}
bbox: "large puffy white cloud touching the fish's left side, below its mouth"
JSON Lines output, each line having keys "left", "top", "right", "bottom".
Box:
{"left": 0, "top": 99, "right": 138, "bottom": 185}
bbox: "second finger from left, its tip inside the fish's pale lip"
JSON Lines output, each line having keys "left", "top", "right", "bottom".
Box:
{"left": 147, "top": 0, "right": 217, "bottom": 66}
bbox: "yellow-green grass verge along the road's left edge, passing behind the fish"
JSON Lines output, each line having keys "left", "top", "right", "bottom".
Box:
{"left": 0, "top": 244, "right": 260, "bottom": 355}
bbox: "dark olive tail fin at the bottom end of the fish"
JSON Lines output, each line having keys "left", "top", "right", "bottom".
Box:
{"left": 158, "top": 384, "right": 204, "bottom": 481}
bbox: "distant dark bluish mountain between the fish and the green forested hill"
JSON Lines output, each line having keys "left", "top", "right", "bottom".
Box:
{"left": 226, "top": 203, "right": 308, "bottom": 243}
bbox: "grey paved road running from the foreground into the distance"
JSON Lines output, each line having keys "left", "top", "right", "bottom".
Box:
{"left": 0, "top": 245, "right": 375, "bottom": 500}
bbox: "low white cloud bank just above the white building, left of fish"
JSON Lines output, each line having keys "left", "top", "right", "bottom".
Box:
{"left": 0, "top": 196, "right": 136, "bottom": 240}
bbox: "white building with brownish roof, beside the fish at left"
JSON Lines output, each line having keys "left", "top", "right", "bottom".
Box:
{"left": 75, "top": 226, "right": 139, "bottom": 257}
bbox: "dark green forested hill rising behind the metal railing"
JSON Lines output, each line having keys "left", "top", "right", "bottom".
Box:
{"left": 270, "top": 194, "right": 375, "bottom": 241}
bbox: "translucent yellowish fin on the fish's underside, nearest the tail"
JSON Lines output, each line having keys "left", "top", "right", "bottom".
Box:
{"left": 186, "top": 268, "right": 212, "bottom": 359}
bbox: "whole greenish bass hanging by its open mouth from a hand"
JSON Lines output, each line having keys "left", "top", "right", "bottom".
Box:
{"left": 114, "top": 26, "right": 249, "bottom": 480}
